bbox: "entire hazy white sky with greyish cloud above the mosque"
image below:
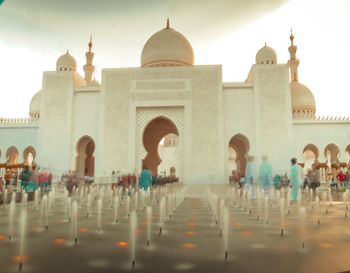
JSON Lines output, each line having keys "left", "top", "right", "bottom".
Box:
{"left": 0, "top": 0, "right": 350, "bottom": 117}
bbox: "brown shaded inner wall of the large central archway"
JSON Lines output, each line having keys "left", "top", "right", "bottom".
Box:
{"left": 142, "top": 117, "right": 179, "bottom": 175}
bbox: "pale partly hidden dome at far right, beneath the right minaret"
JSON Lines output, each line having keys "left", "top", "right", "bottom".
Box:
{"left": 290, "top": 81, "right": 316, "bottom": 113}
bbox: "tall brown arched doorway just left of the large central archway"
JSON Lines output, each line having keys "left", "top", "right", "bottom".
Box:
{"left": 75, "top": 136, "right": 95, "bottom": 176}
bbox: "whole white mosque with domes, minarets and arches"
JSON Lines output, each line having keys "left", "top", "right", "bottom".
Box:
{"left": 0, "top": 21, "right": 350, "bottom": 184}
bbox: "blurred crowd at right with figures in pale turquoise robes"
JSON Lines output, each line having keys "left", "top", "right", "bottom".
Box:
{"left": 230, "top": 156, "right": 350, "bottom": 200}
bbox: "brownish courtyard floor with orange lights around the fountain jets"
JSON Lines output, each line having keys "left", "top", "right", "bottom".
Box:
{"left": 0, "top": 184, "right": 350, "bottom": 273}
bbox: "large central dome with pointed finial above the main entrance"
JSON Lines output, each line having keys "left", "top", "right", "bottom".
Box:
{"left": 141, "top": 21, "right": 194, "bottom": 67}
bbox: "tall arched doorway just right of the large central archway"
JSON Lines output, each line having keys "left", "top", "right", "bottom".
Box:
{"left": 228, "top": 134, "right": 250, "bottom": 175}
